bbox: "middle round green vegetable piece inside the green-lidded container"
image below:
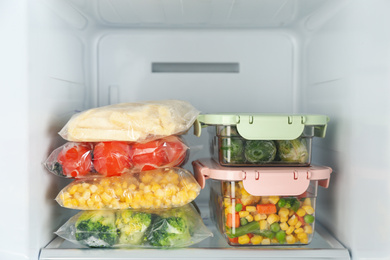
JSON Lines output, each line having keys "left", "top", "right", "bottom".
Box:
{"left": 244, "top": 140, "right": 276, "bottom": 163}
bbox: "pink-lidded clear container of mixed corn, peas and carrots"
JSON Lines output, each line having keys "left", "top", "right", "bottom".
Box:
{"left": 192, "top": 159, "right": 332, "bottom": 246}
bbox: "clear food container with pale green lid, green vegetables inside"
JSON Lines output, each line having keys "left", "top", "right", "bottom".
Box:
{"left": 194, "top": 113, "right": 329, "bottom": 166}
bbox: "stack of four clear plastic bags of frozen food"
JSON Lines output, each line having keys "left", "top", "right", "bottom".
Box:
{"left": 45, "top": 100, "right": 212, "bottom": 248}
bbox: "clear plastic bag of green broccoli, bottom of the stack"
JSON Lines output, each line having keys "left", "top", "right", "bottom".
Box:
{"left": 55, "top": 204, "right": 213, "bottom": 248}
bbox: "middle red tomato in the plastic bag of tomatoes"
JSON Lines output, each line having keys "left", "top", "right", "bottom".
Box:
{"left": 93, "top": 142, "right": 132, "bottom": 177}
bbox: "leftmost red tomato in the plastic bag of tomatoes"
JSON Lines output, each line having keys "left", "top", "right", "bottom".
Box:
{"left": 57, "top": 142, "right": 92, "bottom": 178}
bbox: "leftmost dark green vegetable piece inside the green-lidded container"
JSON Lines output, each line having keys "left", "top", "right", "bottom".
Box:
{"left": 221, "top": 137, "right": 244, "bottom": 163}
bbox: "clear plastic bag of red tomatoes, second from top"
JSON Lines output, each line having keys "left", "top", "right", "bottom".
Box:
{"left": 44, "top": 136, "right": 189, "bottom": 178}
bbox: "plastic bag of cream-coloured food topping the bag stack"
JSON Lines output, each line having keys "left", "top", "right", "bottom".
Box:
{"left": 59, "top": 100, "right": 199, "bottom": 142}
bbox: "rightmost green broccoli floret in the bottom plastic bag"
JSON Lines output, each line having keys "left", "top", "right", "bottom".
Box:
{"left": 147, "top": 216, "right": 191, "bottom": 247}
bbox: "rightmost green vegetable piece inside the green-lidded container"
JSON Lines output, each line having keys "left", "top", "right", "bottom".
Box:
{"left": 276, "top": 138, "right": 309, "bottom": 163}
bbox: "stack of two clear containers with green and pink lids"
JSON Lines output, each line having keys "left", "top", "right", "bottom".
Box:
{"left": 192, "top": 114, "right": 332, "bottom": 246}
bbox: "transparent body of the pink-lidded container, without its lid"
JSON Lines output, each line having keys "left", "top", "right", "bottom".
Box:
{"left": 210, "top": 180, "right": 318, "bottom": 246}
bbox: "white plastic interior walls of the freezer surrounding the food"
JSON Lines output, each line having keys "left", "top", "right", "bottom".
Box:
{"left": 0, "top": 0, "right": 390, "bottom": 260}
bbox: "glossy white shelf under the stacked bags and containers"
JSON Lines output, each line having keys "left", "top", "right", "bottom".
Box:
{"left": 39, "top": 205, "right": 351, "bottom": 260}
